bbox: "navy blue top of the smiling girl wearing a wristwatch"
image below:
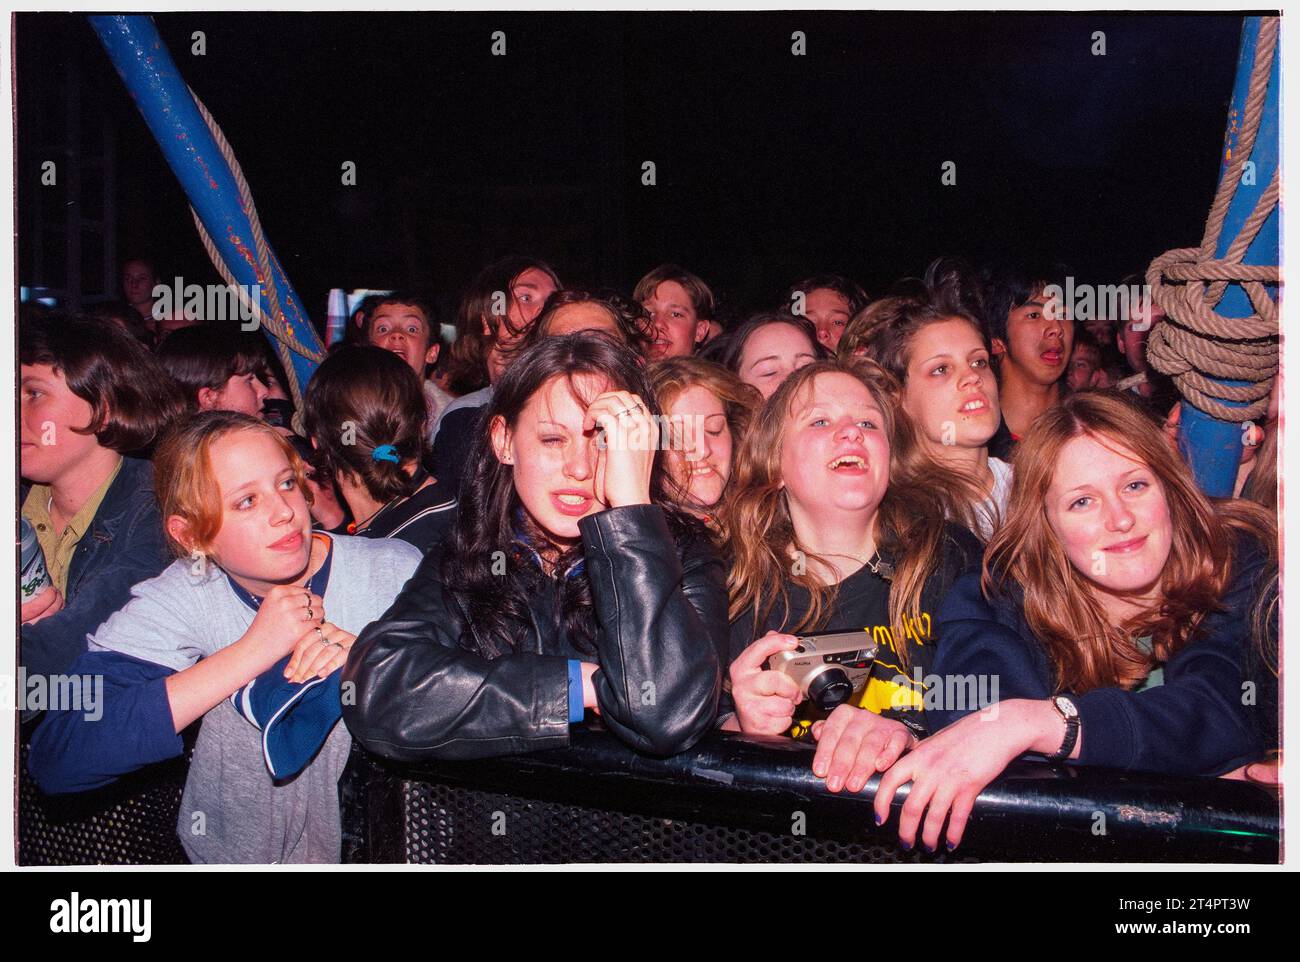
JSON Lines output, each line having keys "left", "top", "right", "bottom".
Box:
{"left": 926, "top": 534, "right": 1268, "bottom": 775}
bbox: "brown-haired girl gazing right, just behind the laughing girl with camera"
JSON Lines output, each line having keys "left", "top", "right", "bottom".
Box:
{"left": 865, "top": 260, "right": 1011, "bottom": 541}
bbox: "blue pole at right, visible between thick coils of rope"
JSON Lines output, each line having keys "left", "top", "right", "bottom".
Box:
{"left": 1179, "top": 17, "right": 1282, "bottom": 497}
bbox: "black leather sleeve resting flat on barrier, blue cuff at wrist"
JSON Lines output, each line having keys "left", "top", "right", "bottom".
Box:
{"left": 343, "top": 549, "right": 569, "bottom": 762}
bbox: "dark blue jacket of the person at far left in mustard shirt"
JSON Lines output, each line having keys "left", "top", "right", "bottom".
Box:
{"left": 20, "top": 458, "right": 172, "bottom": 675}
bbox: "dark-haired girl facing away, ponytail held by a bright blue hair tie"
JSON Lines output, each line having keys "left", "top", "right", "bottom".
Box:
{"left": 303, "top": 347, "right": 456, "bottom": 551}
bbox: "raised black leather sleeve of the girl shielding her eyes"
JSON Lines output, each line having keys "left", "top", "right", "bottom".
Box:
{"left": 579, "top": 504, "right": 728, "bottom": 755}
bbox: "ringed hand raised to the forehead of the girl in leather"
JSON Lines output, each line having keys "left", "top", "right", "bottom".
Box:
{"left": 582, "top": 391, "right": 659, "bottom": 508}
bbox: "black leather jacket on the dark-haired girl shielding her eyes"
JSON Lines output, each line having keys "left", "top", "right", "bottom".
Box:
{"left": 343, "top": 504, "right": 727, "bottom": 761}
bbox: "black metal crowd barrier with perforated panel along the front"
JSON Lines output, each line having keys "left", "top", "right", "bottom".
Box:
{"left": 18, "top": 729, "right": 1281, "bottom": 865}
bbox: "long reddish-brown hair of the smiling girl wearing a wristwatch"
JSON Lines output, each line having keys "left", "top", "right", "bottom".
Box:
{"left": 983, "top": 391, "right": 1277, "bottom": 694}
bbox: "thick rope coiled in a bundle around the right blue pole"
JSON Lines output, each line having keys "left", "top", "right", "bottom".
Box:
{"left": 1147, "top": 17, "right": 1282, "bottom": 423}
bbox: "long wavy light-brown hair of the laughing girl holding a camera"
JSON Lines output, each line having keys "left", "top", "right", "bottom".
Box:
{"left": 720, "top": 359, "right": 977, "bottom": 670}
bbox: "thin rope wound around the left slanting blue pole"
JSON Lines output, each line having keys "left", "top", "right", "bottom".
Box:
{"left": 190, "top": 88, "right": 325, "bottom": 433}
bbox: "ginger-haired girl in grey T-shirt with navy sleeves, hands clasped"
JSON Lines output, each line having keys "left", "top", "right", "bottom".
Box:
{"left": 29, "top": 411, "right": 420, "bottom": 863}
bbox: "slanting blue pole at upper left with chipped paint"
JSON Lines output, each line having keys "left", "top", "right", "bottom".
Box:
{"left": 90, "top": 16, "right": 324, "bottom": 395}
